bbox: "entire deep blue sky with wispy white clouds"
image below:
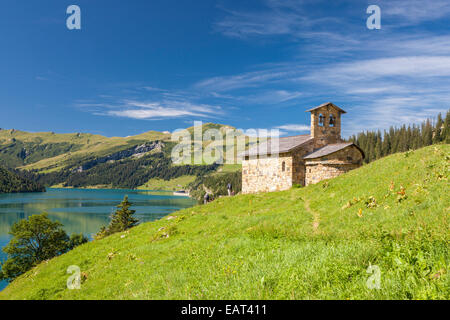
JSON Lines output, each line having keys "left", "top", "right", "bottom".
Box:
{"left": 0, "top": 0, "right": 450, "bottom": 136}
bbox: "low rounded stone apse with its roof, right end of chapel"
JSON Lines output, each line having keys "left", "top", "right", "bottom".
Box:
{"left": 305, "top": 146, "right": 363, "bottom": 185}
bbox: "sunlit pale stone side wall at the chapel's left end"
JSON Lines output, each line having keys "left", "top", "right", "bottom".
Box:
{"left": 242, "top": 153, "right": 293, "bottom": 193}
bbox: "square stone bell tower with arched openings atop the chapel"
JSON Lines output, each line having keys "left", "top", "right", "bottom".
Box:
{"left": 306, "top": 102, "right": 346, "bottom": 149}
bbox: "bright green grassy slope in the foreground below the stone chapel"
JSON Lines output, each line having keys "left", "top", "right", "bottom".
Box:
{"left": 0, "top": 145, "right": 450, "bottom": 299}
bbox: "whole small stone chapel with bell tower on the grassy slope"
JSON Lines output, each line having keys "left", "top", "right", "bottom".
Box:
{"left": 242, "top": 102, "right": 364, "bottom": 193}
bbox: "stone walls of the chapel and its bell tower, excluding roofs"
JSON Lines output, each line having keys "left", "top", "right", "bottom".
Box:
{"left": 242, "top": 104, "right": 363, "bottom": 193}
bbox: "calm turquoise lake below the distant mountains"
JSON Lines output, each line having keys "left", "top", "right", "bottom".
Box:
{"left": 0, "top": 189, "right": 197, "bottom": 290}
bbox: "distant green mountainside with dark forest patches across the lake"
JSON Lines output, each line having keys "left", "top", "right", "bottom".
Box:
{"left": 0, "top": 123, "right": 243, "bottom": 189}
